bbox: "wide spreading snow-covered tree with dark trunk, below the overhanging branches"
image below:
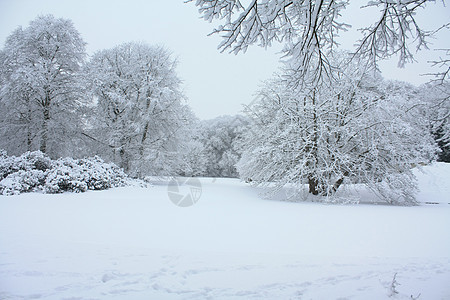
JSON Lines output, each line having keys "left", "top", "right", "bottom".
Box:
{"left": 238, "top": 59, "right": 436, "bottom": 204}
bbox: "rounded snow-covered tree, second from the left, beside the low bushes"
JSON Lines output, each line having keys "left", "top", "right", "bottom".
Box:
{"left": 86, "top": 43, "right": 193, "bottom": 176}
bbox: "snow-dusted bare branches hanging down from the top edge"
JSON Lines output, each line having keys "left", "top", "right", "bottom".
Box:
{"left": 187, "top": 0, "right": 448, "bottom": 81}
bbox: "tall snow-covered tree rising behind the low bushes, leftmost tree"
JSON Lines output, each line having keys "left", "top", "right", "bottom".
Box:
{"left": 0, "top": 15, "right": 86, "bottom": 157}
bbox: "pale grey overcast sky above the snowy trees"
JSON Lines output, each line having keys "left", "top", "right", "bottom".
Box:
{"left": 0, "top": 0, "right": 450, "bottom": 119}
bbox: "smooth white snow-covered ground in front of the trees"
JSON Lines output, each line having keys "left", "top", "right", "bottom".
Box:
{"left": 0, "top": 163, "right": 450, "bottom": 300}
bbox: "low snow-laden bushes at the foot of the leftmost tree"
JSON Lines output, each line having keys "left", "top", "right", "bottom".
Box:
{"left": 0, "top": 151, "right": 127, "bottom": 195}
